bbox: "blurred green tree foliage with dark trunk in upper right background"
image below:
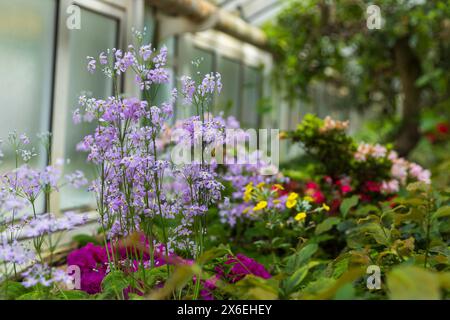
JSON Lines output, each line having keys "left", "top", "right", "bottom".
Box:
{"left": 264, "top": 0, "right": 450, "bottom": 166}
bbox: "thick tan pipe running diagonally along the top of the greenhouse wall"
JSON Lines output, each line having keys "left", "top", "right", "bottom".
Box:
{"left": 147, "top": 0, "right": 268, "bottom": 50}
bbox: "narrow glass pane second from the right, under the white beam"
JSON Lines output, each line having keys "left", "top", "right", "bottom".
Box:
{"left": 216, "top": 57, "right": 240, "bottom": 119}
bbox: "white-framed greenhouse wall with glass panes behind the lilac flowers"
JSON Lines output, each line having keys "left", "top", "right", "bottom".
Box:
{"left": 0, "top": 0, "right": 274, "bottom": 224}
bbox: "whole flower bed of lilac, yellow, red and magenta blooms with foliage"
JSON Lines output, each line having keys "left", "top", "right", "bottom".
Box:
{"left": 0, "top": 32, "right": 450, "bottom": 299}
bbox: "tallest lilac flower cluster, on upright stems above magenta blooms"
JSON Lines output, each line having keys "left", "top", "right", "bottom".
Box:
{"left": 78, "top": 32, "right": 227, "bottom": 264}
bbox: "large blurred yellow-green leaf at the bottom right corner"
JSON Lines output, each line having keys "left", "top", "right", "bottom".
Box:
{"left": 387, "top": 266, "right": 441, "bottom": 300}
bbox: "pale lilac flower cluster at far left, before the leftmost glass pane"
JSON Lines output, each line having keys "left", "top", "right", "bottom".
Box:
{"left": 0, "top": 132, "right": 87, "bottom": 286}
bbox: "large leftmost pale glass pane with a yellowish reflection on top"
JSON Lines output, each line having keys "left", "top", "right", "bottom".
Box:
{"left": 0, "top": 0, "right": 56, "bottom": 171}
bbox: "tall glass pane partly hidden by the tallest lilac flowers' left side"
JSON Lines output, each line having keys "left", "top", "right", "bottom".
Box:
{"left": 61, "top": 9, "right": 118, "bottom": 209}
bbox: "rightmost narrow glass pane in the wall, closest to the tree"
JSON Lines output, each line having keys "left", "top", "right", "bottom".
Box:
{"left": 241, "top": 66, "right": 262, "bottom": 128}
